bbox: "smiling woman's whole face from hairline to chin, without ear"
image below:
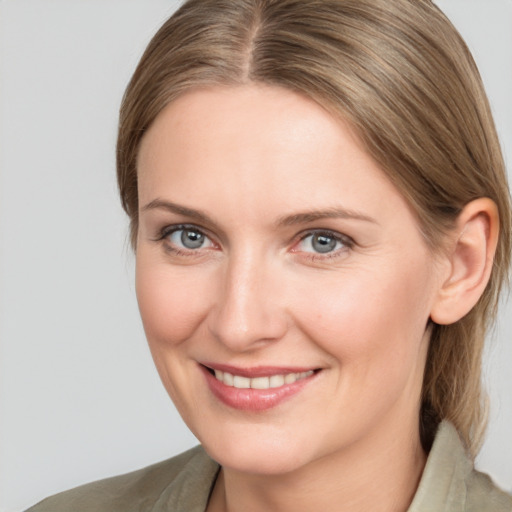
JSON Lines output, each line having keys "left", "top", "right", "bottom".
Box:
{"left": 137, "top": 85, "right": 441, "bottom": 474}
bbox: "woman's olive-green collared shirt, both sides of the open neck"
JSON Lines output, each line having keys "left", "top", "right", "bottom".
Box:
{"left": 27, "top": 421, "right": 512, "bottom": 512}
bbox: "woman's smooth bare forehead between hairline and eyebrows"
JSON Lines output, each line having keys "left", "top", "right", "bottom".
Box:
{"left": 138, "top": 85, "right": 416, "bottom": 228}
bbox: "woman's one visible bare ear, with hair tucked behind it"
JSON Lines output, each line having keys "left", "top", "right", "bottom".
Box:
{"left": 430, "top": 197, "right": 499, "bottom": 325}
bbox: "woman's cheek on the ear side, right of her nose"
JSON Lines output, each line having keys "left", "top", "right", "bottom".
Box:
{"left": 295, "top": 264, "right": 429, "bottom": 373}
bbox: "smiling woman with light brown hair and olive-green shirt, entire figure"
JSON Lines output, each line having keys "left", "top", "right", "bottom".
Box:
{"left": 27, "top": 0, "right": 512, "bottom": 512}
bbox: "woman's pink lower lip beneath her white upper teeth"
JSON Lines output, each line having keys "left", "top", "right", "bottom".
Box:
{"left": 200, "top": 365, "right": 317, "bottom": 411}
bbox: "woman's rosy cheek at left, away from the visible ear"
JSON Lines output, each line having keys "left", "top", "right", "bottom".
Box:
{"left": 136, "top": 258, "right": 210, "bottom": 347}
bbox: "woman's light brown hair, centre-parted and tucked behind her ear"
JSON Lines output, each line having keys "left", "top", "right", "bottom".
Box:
{"left": 117, "top": 0, "right": 511, "bottom": 454}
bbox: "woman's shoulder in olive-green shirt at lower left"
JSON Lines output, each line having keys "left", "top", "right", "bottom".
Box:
{"left": 27, "top": 446, "right": 218, "bottom": 512}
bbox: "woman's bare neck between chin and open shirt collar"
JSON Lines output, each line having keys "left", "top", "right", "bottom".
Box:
{"left": 208, "top": 412, "right": 426, "bottom": 512}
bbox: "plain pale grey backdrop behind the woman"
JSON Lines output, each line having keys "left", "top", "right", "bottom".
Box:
{"left": 0, "top": 0, "right": 512, "bottom": 512}
